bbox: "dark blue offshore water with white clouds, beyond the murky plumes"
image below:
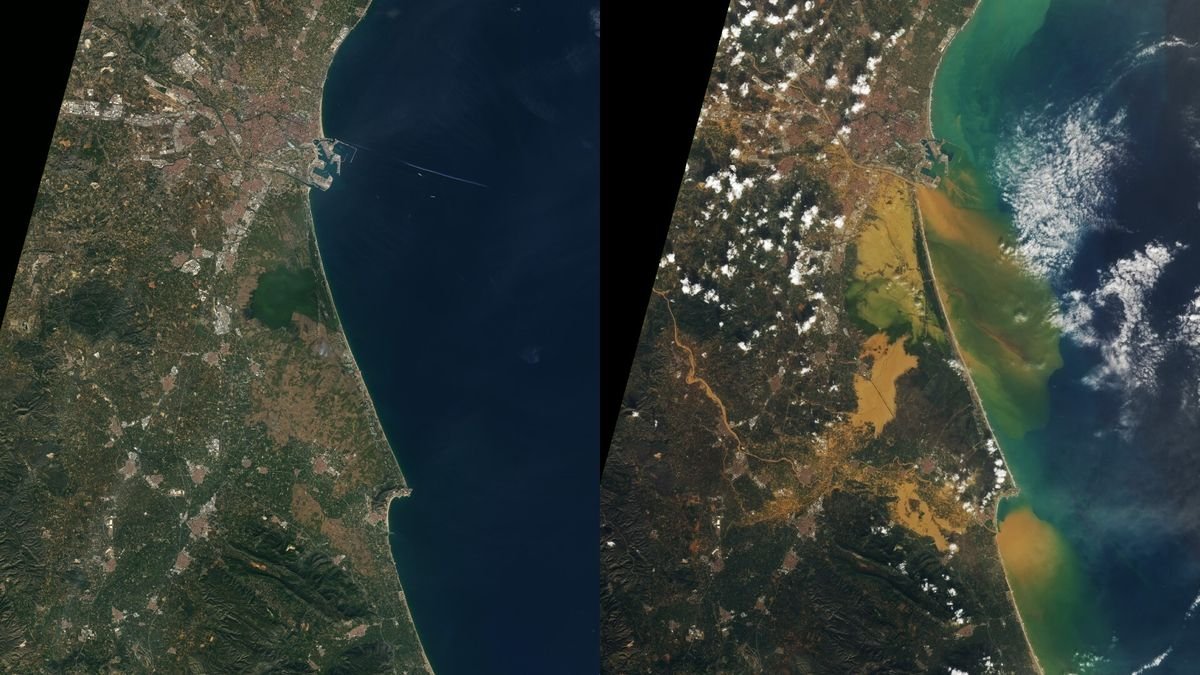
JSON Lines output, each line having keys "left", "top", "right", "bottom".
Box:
{"left": 984, "top": 0, "right": 1200, "bottom": 675}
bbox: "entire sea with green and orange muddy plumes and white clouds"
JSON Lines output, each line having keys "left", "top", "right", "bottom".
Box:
{"left": 922, "top": 0, "right": 1200, "bottom": 673}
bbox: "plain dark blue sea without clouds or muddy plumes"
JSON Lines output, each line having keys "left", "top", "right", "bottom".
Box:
{"left": 312, "top": 0, "right": 600, "bottom": 675}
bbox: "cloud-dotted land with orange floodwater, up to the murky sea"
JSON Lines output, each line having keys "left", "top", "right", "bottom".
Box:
{"left": 599, "top": 0, "right": 1036, "bottom": 673}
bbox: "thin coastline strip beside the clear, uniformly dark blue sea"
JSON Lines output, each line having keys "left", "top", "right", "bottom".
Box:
{"left": 305, "top": 0, "right": 434, "bottom": 674}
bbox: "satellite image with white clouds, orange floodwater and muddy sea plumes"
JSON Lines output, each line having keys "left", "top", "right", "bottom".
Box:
{"left": 599, "top": 0, "right": 1200, "bottom": 674}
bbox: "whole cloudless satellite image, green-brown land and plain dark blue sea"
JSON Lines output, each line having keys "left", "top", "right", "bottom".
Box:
{"left": 0, "top": 0, "right": 600, "bottom": 674}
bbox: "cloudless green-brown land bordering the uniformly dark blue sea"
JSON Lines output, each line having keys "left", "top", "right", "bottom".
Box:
{"left": 0, "top": 0, "right": 430, "bottom": 673}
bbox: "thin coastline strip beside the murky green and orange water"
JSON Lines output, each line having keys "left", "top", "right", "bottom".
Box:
{"left": 912, "top": 0, "right": 1045, "bottom": 675}
